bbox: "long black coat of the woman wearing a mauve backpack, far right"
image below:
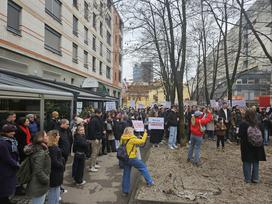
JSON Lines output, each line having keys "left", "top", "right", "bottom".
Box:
{"left": 238, "top": 122, "right": 266, "bottom": 162}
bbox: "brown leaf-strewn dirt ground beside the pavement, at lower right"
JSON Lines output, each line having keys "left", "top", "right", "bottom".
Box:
{"left": 136, "top": 141, "right": 272, "bottom": 204}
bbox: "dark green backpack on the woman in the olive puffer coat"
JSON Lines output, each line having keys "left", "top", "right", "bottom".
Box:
{"left": 16, "top": 156, "right": 32, "bottom": 185}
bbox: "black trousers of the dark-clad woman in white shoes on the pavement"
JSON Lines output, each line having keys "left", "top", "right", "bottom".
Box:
{"left": 72, "top": 153, "right": 86, "bottom": 183}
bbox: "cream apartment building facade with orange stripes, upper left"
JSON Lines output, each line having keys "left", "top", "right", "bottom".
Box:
{"left": 0, "top": 0, "right": 123, "bottom": 98}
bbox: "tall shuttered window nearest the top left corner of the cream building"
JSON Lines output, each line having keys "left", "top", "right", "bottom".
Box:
{"left": 7, "top": 1, "right": 22, "bottom": 35}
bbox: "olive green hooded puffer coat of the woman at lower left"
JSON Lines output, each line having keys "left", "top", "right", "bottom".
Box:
{"left": 24, "top": 144, "right": 51, "bottom": 197}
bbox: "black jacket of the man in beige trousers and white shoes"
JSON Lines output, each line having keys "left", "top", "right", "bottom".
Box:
{"left": 87, "top": 116, "right": 104, "bottom": 140}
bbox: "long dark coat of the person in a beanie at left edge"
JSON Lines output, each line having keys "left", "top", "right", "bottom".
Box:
{"left": 0, "top": 136, "right": 19, "bottom": 197}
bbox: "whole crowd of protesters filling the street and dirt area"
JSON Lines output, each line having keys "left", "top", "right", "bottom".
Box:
{"left": 0, "top": 103, "right": 272, "bottom": 204}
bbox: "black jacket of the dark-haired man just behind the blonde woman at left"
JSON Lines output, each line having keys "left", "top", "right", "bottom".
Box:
{"left": 59, "top": 128, "right": 73, "bottom": 160}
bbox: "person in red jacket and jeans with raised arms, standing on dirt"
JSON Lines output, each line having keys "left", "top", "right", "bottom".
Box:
{"left": 187, "top": 109, "right": 213, "bottom": 166}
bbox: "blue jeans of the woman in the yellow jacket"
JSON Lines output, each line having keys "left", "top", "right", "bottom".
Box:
{"left": 122, "top": 158, "right": 153, "bottom": 193}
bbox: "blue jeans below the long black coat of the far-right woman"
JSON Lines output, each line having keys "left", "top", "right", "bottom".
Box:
{"left": 243, "top": 161, "right": 259, "bottom": 182}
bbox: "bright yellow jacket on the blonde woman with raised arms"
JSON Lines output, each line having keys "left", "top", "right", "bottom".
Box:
{"left": 120, "top": 132, "right": 147, "bottom": 159}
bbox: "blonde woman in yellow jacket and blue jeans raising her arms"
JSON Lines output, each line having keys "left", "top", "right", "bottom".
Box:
{"left": 121, "top": 127, "right": 154, "bottom": 196}
